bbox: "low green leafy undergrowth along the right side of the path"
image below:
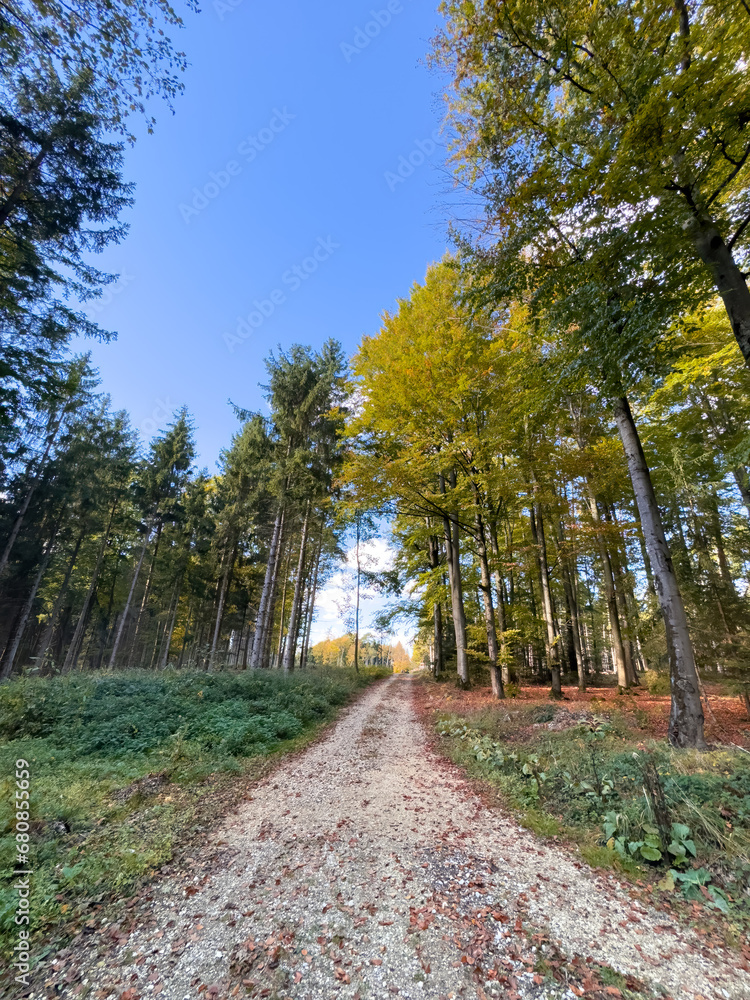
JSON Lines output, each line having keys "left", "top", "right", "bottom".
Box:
{"left": 437, "top": 702, "right": 750, "bottom": 937}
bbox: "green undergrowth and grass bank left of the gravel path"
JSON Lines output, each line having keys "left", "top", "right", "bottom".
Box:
{"left": 0, "top": 670, "right": 383, "bottom": 958}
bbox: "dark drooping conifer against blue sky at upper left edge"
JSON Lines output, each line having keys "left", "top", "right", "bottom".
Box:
{"left": 0, "top": 70, "right": 132, "bottom": 427}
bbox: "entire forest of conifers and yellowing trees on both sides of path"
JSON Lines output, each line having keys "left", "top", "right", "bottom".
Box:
{"left": 0, "top": 0, "right": 750, "bottom": 747}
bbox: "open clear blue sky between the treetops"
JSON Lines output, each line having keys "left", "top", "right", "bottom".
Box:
{"left": 82, "top": 0, "right": 450, "bottom": 471}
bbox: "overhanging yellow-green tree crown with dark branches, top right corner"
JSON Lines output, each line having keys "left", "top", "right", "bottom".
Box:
{"left": 436, "top": 0, "right": 750, "bottom": 362}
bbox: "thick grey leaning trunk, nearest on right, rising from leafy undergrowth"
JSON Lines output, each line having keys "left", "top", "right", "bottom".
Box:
{"left": 615, "top": 396, "right": 706, "bottom": 749}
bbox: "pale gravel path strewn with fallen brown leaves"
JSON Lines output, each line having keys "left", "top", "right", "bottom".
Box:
{"left": 33, "top": 678, "right": 750, "bottom": 1000}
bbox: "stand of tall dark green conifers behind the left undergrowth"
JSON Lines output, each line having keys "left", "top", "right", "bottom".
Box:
{"left": 0, "top": 341, "right": 346, "bottom": 677}
